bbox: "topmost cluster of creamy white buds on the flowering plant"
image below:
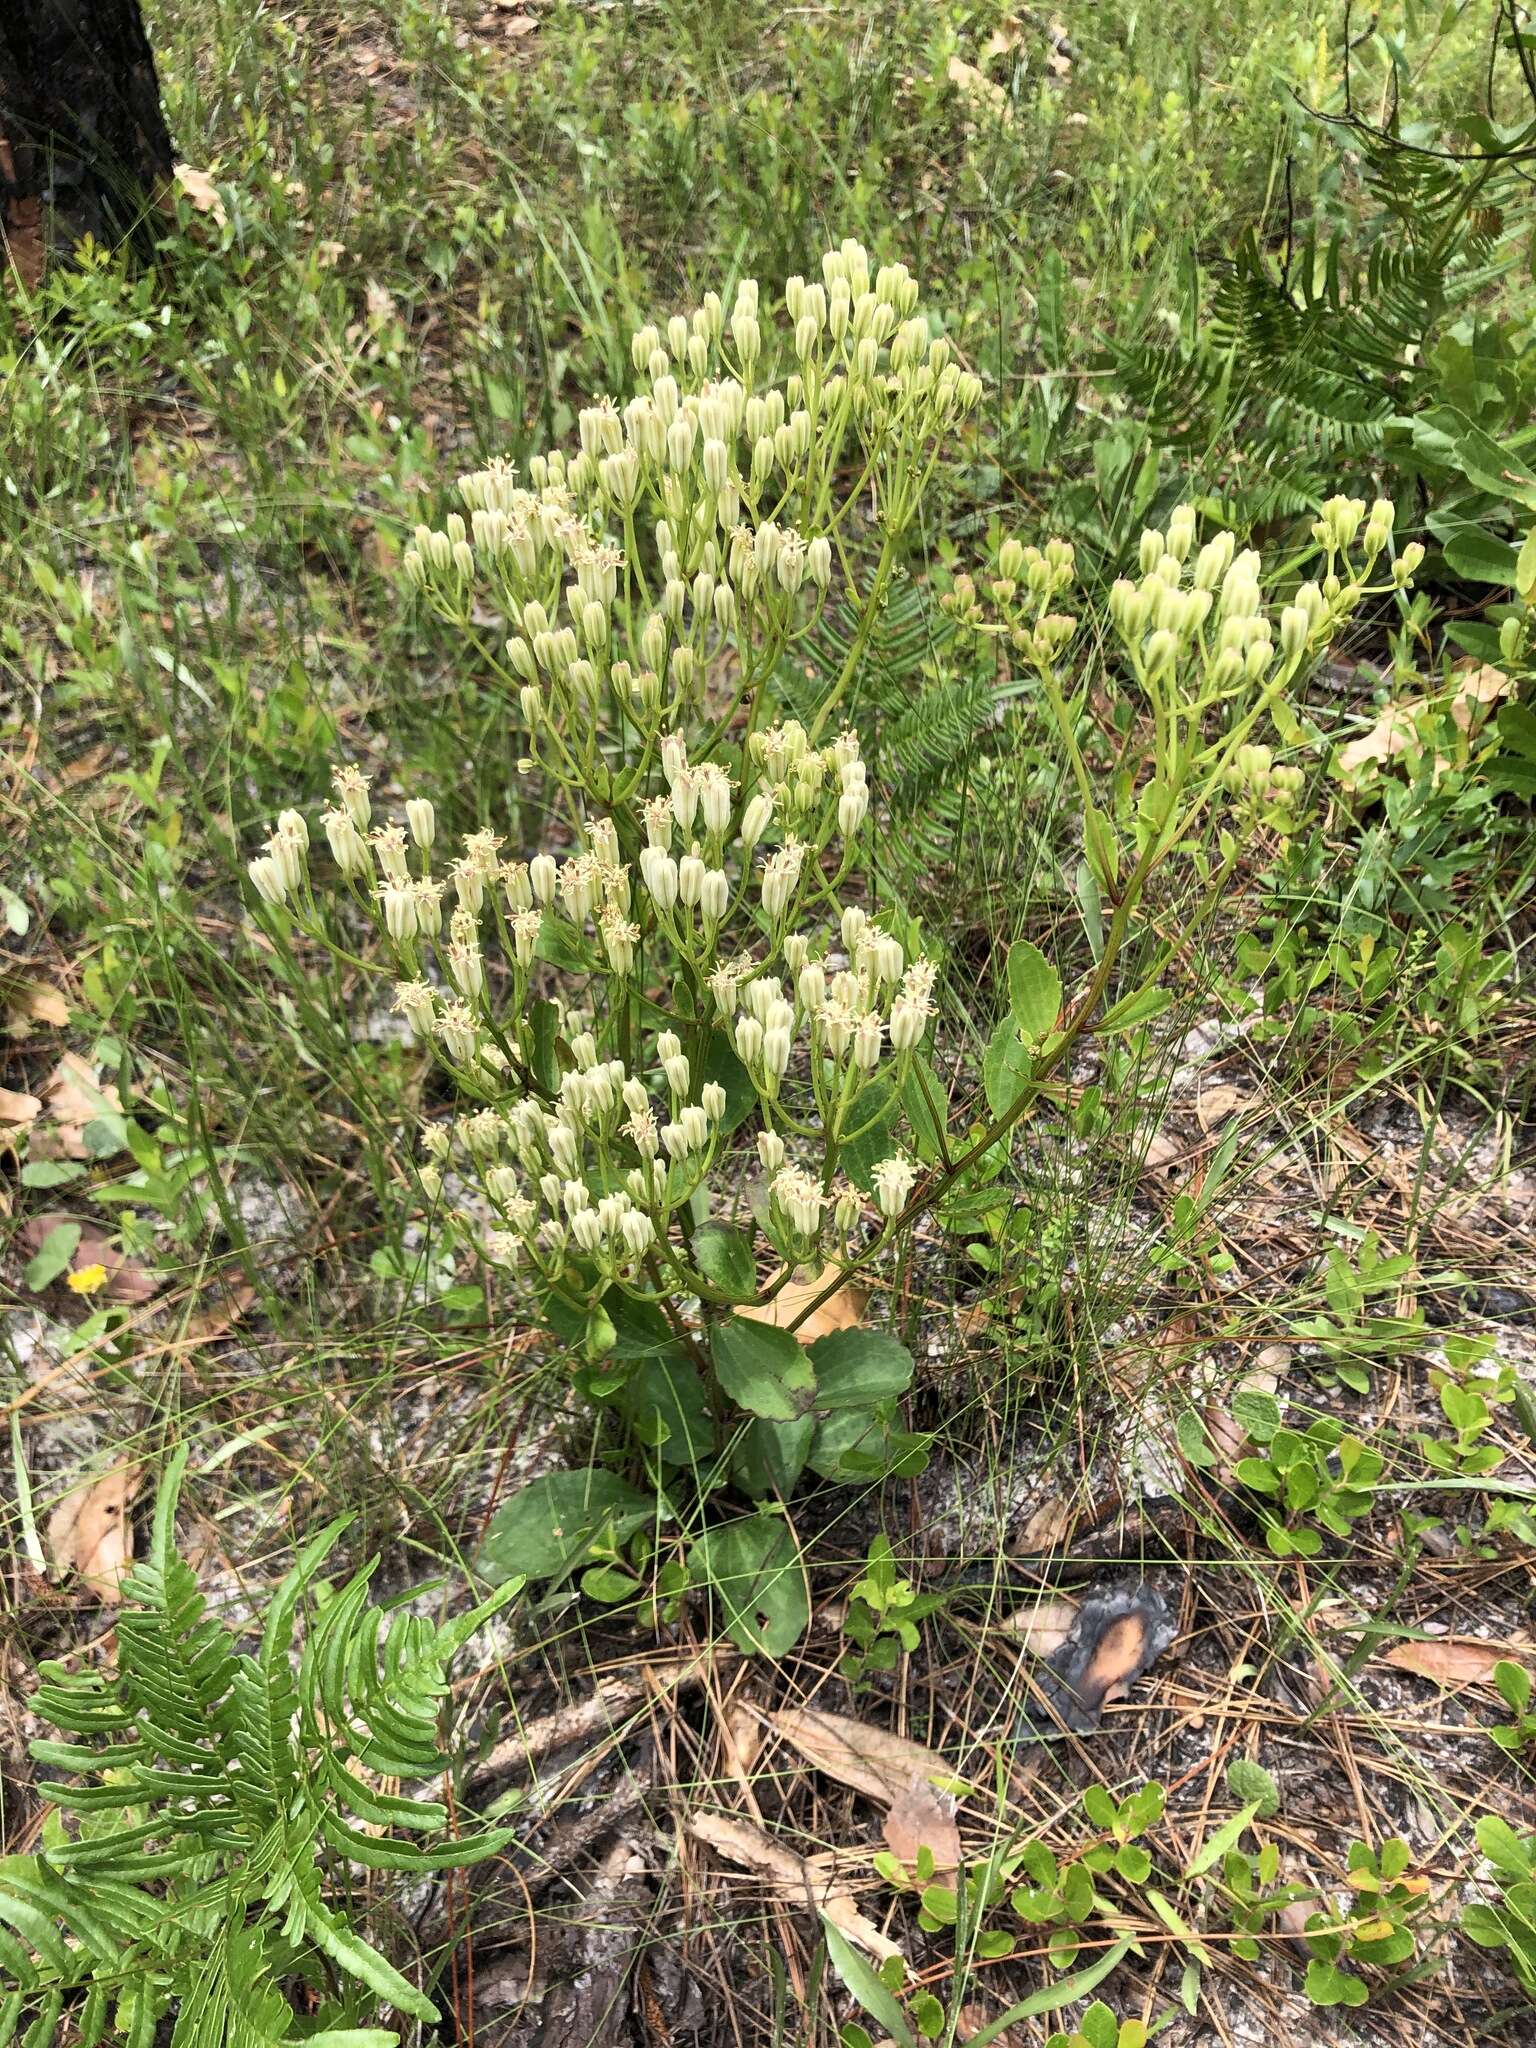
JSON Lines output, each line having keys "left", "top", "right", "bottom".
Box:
{"left": 393, "top": 242, "right": 981, "bottom": 778}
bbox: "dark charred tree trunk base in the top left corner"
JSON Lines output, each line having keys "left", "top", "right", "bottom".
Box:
{"left": 0, "top": 0, "right": 172, "bottom": 268}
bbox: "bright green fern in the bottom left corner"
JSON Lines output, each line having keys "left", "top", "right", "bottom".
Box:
{"left": 0, "top": 1454, "right": 516, "bottom": 2048}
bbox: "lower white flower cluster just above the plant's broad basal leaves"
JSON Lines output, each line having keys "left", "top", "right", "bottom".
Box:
{"left": 250, "top": 721, "right": 936, "bottom": 1298}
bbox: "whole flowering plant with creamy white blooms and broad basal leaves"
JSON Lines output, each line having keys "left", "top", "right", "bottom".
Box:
{"left": 250, "top": 242, "right": 1433, "bottom": 1649}
